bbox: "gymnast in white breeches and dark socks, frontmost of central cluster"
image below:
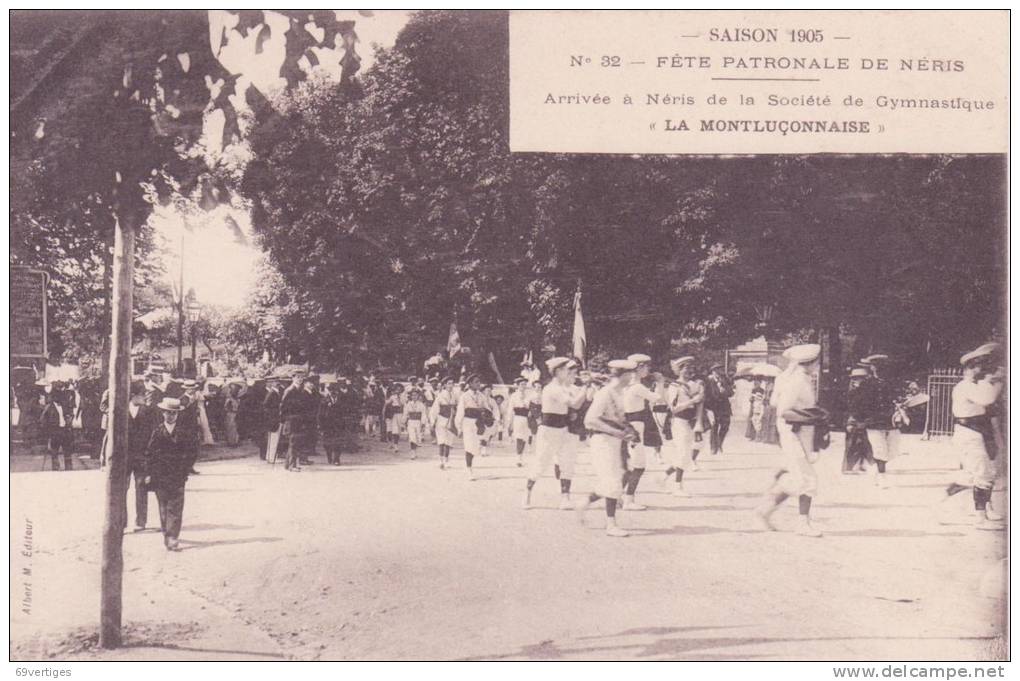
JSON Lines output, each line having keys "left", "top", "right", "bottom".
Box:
{"left": 577, "top": 360, "right": 641, "bottom": 537}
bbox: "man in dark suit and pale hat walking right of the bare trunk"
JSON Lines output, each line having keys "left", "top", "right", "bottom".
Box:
{"left": 144, "top": 398, "right": 194, "bottom": 551}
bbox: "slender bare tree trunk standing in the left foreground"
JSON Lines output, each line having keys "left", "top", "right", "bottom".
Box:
{"left": 99, "top": 212, "right": 136, "bottom": 648}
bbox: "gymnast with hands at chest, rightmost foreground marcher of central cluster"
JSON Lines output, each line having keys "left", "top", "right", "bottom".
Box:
{"left": 663, "top": 356, "right": 705, "bottom": 496}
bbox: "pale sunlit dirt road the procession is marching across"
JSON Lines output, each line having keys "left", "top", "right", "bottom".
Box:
{"left": 10, "top": 436, "right": 1006, "bottom": 660}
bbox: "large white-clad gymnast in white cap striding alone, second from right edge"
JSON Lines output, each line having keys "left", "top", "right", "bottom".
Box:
{"left": 755, "top": 344, "right": 822, "bottom": 537}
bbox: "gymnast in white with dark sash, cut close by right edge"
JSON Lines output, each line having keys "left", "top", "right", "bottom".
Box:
{"left": 946, "top": 343, "right": 1005, "bottom": 530}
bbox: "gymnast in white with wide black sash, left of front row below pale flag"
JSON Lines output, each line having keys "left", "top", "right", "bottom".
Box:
{"left": 523, "top": 357, "right": 584, "bottom": 510}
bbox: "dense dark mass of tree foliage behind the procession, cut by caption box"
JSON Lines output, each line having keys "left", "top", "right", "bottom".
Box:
{"left": 242, "top": 11, "right": 1005, "bottom": 373}
